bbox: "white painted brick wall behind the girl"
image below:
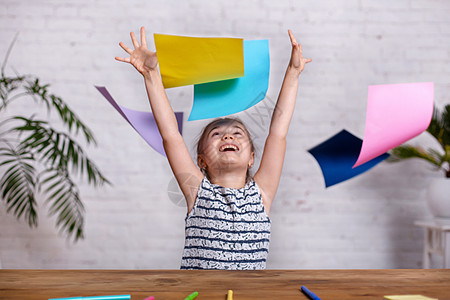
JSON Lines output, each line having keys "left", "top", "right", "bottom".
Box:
{"left": 0, "top": 0, "right": 450, "bottom": 269}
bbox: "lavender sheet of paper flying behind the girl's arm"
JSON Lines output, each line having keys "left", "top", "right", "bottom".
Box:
{"left": 95, "top": 86, "right": 183, "bottom": 156}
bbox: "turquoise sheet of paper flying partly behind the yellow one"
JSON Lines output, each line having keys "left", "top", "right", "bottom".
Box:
{"left": 189, "top": 40, "right": 270, "bottom": 121}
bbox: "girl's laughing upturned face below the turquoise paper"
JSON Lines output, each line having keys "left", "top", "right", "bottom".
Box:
{"left": 199, "top": 122, "right": 254, "bottom": 171}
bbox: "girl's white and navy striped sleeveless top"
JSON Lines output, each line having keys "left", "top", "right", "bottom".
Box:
{"left": 181, "top": 177, "right": 271, "bottom": 270}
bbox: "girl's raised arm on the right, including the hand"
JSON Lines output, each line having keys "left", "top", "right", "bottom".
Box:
{"left": 253, "top": 30, "right": 311, "bottom": 213}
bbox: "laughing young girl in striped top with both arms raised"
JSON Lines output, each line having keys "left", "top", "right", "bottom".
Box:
{"left": 116, "top": 27, "right": 311, "bottom": 270}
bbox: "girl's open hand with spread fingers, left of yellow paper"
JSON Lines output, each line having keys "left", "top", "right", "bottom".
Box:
{"left": 116, "top": 27, "right": 158, "bottom": 76}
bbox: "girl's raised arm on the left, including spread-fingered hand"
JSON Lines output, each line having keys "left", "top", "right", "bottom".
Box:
{"left": 116, "top": 27, "right": 203, "bottom": 211}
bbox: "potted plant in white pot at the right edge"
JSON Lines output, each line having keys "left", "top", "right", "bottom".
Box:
{"left": 389, "top": 104, "right": 450, "bottom": 219}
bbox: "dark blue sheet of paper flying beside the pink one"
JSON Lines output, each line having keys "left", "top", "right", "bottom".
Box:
{"left": 308, "top": 129, "right": 389, "bottom": 187}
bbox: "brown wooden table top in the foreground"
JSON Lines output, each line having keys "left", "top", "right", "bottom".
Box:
{"left": 0, "top": 269, "right": 450, "bottom": 300}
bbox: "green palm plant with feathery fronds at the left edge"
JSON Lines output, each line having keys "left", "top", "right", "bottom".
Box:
{"left": 0, "top": 36, "right": 109, "bottom": 241}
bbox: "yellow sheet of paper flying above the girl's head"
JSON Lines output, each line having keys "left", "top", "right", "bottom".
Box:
{"left": 154, "top": 33, "right": 244, "bottom": 88}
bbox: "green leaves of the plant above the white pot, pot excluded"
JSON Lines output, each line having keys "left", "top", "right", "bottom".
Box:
{"left": 389, "top": 104, "right": 450, "bottom": 178}
